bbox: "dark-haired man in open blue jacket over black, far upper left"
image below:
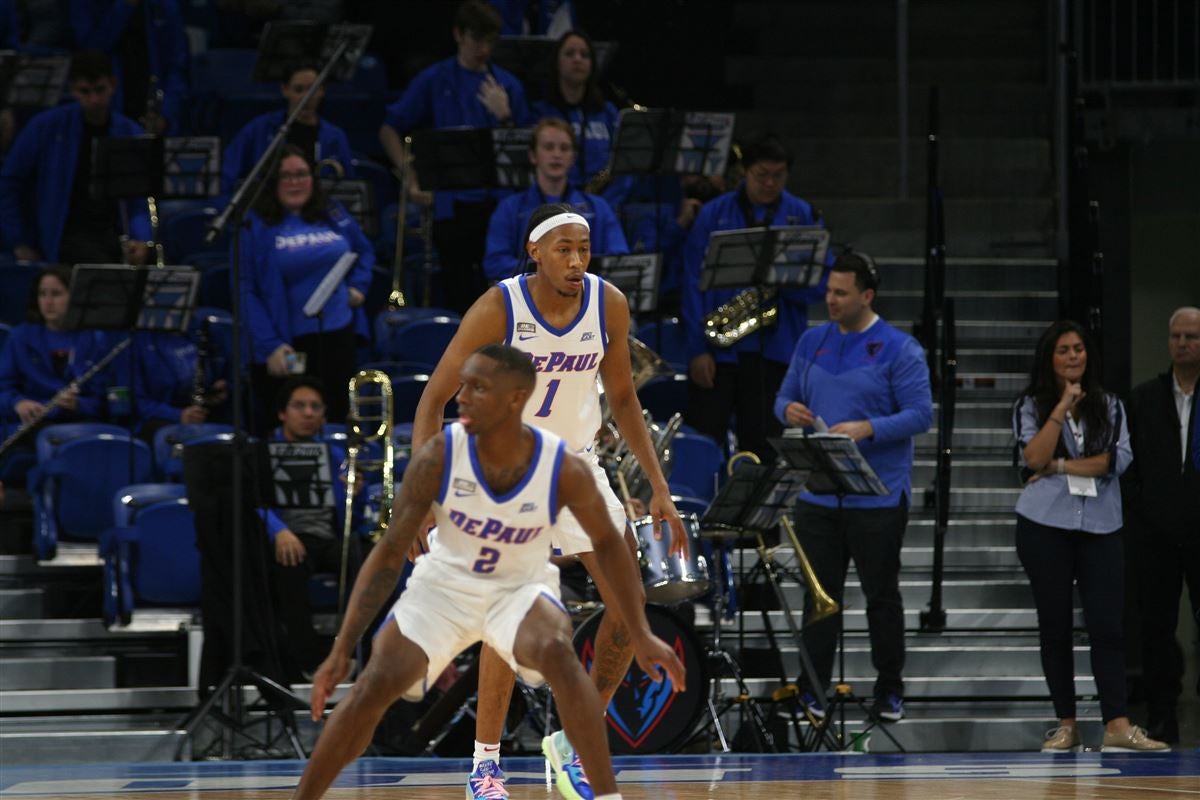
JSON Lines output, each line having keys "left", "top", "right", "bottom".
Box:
{"left": 0, "top": 50, "right": 150, "bottom": 264}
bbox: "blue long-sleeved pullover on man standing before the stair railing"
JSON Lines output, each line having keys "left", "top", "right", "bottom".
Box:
{"left": 775, "top": 318, "right": 934, "bottom": 509}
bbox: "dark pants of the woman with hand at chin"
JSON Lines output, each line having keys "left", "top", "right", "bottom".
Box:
{"left": 1016, "top": 515, "right": 1126, "bottom": 722}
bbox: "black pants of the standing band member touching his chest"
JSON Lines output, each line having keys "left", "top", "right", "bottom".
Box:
{"left": 433, "top": 200, "right": 492, "bottom": 314}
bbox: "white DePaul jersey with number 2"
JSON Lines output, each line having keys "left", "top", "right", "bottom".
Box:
{"left": 427, "top": 422, "right": 566, "bottom": 583}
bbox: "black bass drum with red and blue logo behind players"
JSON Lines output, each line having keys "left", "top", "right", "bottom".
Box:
{"left": 575, "top": 606, "right": 708, "bottom": 756}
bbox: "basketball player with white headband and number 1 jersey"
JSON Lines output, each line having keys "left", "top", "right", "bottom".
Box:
{"left": 413, "top": 204, "right": 686, "bottom": 800}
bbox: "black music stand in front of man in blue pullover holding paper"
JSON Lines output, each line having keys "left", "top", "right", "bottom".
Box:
{"left": 768, "top": 428, "right": 905, "bottom": 753}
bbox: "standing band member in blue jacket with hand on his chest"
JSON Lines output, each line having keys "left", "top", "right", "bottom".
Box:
{"left": 379, "top": 0, "right": 530, "bottom": 313}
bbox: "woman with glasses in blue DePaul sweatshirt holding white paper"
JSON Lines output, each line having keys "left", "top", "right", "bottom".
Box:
{"left": 240, "top": 145, "right": 374, "bottom": 435}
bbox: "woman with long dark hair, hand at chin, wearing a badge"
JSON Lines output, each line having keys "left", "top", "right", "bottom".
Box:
{"left": 1013, "top": 320, "right": 1168, "bottom": 752}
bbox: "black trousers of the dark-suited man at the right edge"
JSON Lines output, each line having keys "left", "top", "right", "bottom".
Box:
{"left": 1135, "top": 523, "right": 1200, "bottom": 732}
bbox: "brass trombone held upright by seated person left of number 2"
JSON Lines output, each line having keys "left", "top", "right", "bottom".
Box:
{"left": 337, "top": 369, "right": 396, "bottom": 619}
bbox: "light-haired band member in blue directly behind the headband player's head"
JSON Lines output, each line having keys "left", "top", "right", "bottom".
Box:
{"left": 484, "top": 118, "right": 629, "bottom": 282}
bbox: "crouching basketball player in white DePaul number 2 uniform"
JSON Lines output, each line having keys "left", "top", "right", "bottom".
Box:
{"left": 293, "top": 344, "right": 685, "bottom": 800}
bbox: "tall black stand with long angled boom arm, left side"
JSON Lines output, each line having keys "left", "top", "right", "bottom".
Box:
{"left": 187, "top": 17, "right": 371, "bottom": 758}
